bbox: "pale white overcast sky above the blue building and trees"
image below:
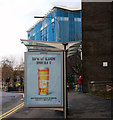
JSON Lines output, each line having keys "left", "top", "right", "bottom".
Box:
{"left": 0, "top": 0, "right": 81, "bottom": 63}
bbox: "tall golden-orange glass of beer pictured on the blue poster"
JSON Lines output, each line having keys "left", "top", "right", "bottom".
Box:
{"left": 38, "top": 67, "right": 49, "bottom": 95}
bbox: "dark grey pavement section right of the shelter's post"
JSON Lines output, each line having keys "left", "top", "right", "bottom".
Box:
{"left": 69, "top": 92, "right": 111, "bottom": 119}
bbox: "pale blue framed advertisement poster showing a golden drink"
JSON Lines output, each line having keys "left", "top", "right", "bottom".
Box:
{"left": 25, "top": 52, "right": 63, "bottom": 107}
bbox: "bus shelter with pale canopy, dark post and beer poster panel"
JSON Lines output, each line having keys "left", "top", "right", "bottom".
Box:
{"left": 21, "top": 39, "right": 81, "bottom": 119}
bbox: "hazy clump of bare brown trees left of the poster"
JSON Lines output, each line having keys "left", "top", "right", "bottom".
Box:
{"left": 1, "top": 56, "right": 24, "bottom": 90}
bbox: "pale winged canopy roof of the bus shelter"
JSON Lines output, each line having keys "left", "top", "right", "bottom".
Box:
{"left": 21, "top": 39, "right": 82, "bottom": 56}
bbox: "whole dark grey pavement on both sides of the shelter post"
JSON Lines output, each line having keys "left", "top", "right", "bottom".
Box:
{"left": 1, "top": 91, "right": 112, "bottom": 119}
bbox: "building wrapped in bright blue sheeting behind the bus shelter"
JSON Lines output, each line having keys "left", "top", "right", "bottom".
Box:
{"left": 27, "top": 6, "right": 82, "bottom": 43}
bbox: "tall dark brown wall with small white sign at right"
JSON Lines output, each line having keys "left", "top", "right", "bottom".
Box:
{"left": 82, "top": 2, "right": 113, "bottom": 93}
